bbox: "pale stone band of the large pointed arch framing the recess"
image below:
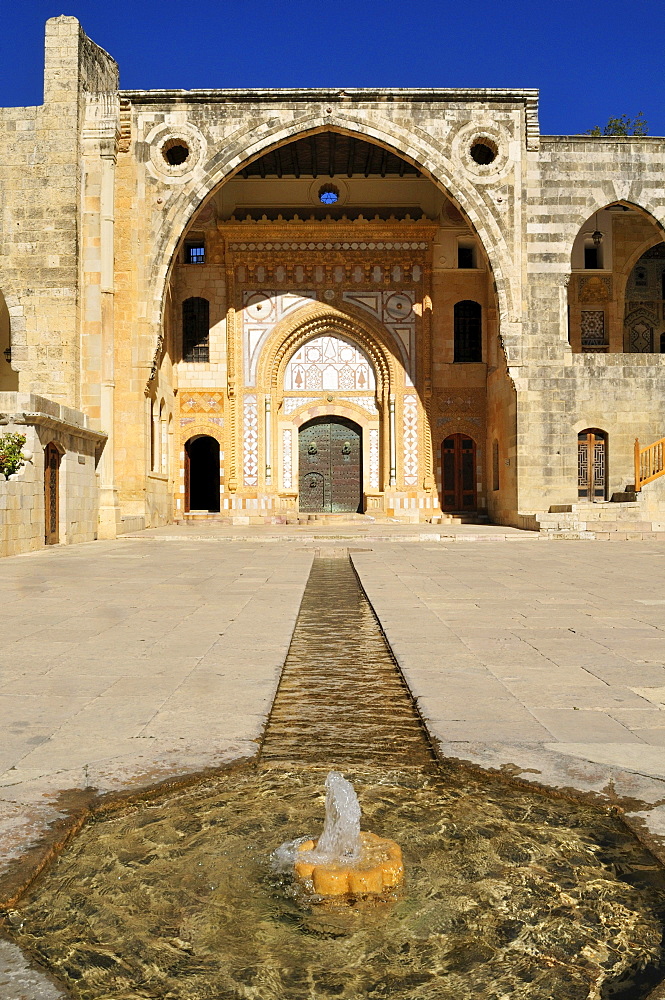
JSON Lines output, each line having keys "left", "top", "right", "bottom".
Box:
{"left": 146, "top": 109, "right": 520, "bottom": 378}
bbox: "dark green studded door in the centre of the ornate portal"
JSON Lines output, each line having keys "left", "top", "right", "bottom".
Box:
{"left": 298, "top": 417, "right": 363, "bottom": 514}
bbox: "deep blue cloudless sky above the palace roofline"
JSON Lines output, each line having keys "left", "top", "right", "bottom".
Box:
{"left": 0, "top": 0, "right": 665, "bottom": 136}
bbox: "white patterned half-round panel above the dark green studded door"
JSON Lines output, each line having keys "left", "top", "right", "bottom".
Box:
{"left": 284, "top": 336, "right": 376, "bottom": 392}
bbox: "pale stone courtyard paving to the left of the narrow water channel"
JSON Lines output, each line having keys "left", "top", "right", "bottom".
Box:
{"left": 0, "top": 539, "right": 313, "bottom": 892}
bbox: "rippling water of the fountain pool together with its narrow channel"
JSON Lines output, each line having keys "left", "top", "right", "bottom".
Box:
{"left": 3, "top": 559, "right": 665, "bottom": 1000}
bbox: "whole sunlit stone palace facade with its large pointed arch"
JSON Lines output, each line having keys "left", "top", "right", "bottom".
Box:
{"left": 0, "top": 17, "right": 665, "bottom": 552}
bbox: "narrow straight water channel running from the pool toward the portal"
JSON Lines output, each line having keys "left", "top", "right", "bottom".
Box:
{"left": 261, "top": 558, "right": 433, "bottom": 768}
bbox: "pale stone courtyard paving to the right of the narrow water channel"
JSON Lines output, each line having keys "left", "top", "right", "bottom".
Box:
{"left": 351, "top": 540, "right": 665, "bottom": 860}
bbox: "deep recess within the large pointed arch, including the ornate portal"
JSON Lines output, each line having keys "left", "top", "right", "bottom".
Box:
{"left": 149, "top": 130, "right": 504, "bottom": 521}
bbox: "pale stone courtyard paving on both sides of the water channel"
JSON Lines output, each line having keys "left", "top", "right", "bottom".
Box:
{"left": 0, "top": 525, "right": 665, "bottom": 1000}
